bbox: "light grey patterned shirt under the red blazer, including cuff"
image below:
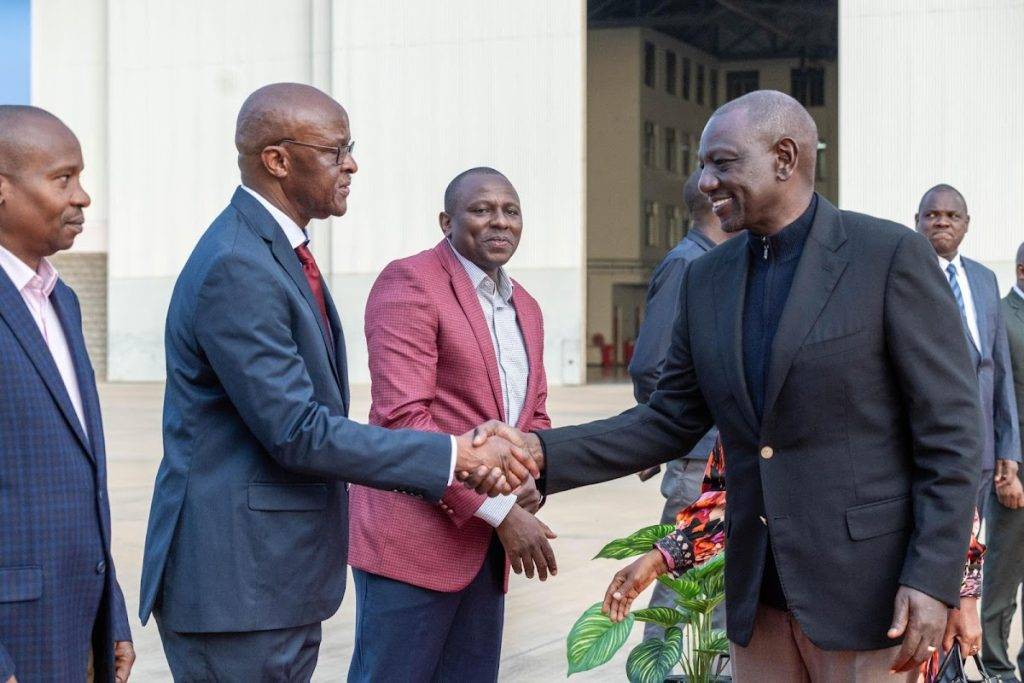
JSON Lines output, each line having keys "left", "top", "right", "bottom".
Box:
{"left": 449, "top": 242, "right": 529, "bottom": 526}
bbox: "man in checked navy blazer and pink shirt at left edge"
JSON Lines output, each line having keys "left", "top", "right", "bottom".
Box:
{"left": 0, "top": 105, "right": 135, "bottom": 683}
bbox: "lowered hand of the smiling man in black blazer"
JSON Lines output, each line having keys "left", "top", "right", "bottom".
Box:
{"left": 887, "top": 586, "right": 949, "bottom": 673}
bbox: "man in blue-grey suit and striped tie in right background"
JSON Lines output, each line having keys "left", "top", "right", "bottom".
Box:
{"left": 914, "top": 184, "right": 1021, "bottom": 519}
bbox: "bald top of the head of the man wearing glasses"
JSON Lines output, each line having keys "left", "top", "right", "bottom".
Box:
{"left": 234, "top": 83, "right": 348, "bottom": 156}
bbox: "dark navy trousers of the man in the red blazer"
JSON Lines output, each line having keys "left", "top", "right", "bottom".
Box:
{"left": 348, "top": 536, "right": 505, "bottom": 683}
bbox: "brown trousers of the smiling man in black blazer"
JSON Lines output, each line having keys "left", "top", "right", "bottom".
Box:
{"left": 730, "top": 605, "right": 907, "bottom": 683}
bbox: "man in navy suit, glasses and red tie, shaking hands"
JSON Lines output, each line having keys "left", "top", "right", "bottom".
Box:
{"left": 139, "top": 83, "right": 539, "bottom": 681}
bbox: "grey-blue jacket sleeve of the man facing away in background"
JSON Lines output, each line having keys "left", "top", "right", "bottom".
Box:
{"left": 630, "top": 258, "right": 688, "bottom": 403}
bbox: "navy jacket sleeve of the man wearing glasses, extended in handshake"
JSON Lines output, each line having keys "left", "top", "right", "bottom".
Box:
{"left": 195, "top": 254, "right": 452, "bottom": 500}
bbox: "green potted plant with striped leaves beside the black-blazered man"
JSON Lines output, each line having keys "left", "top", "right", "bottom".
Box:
{"left": 566, "top": 524, "right": 732, "bottom": 683}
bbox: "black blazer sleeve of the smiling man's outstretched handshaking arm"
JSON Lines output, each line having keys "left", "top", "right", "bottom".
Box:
{"left": 538, "top": 260, "right": 716, "bottom": 491}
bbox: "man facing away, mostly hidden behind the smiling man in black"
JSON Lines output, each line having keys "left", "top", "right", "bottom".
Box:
{"left": 630, "top": 169, "right": 737, "bottom": 638}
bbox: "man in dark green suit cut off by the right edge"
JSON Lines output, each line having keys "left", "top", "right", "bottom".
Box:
{"left": 981, "top": 244, "right": 1024, "bottom": 681}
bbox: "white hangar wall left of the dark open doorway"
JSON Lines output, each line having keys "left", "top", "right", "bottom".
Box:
{"left": 33, "top": 0, "right": 586, "bottom": 384}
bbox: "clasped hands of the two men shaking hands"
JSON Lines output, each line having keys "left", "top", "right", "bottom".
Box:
{"left": 455, "top": 420, "right": 544, "bottom": 497}
